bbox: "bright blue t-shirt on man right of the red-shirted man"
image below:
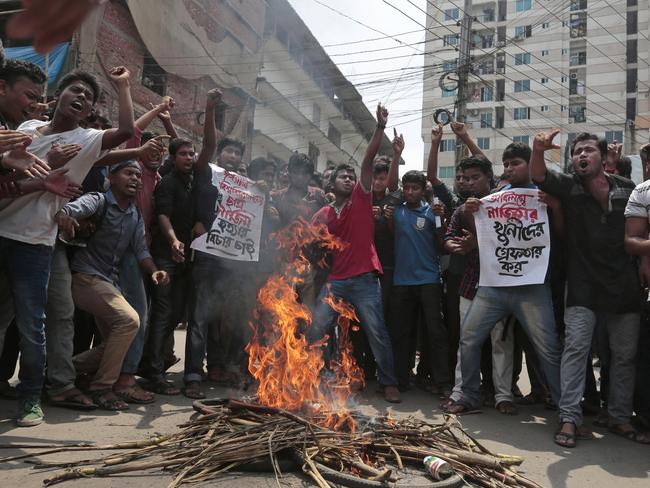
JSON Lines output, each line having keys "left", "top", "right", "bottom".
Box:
{"left": 393, "top": 202, "right": 440, "bottom": 286}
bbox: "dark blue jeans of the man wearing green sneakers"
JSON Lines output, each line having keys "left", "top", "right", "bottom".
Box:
{"left": 0, "top": 237, "right": 52, "bottom": 397}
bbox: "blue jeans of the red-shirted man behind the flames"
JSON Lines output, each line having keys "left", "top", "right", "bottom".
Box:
{"left": 308, "top": 273, "right": 397, "bottom": 386}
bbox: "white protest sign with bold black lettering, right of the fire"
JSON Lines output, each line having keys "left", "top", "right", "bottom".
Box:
{"left": 474, "top": 188, "right": 551, "bottom": 286}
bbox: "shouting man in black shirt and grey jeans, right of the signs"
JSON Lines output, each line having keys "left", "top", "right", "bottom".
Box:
{"left": 531, "top": 130, "right": 647, "bottom": 447}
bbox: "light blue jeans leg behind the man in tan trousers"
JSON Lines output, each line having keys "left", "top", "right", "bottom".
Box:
{"left": 120, "top": 249, "right": 148, "bottom": 374}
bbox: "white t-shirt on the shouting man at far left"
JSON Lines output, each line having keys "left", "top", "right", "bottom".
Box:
{"left": 0, "top": 120, "right": 104, "bottom": 246}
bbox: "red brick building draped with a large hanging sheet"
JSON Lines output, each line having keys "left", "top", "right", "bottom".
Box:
{"left": 76, "top": 0, "right": 265, "bottom": 151}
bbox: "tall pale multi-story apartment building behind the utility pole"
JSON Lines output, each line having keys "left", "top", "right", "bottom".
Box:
{"left": 422, "top": 0, "right": 650, "bottom": 182}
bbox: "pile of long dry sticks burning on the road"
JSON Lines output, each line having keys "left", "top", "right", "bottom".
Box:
{"left": 2, "top": 400, "right": 541, "bottom": 488}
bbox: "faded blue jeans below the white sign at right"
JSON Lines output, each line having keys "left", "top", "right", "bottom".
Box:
{"left": 460, "top": 285, "right": 561, "bottom": 407}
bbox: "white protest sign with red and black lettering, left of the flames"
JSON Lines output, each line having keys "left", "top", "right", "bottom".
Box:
{"left": 191, "top": 164, "right": 266, "bottom": 261}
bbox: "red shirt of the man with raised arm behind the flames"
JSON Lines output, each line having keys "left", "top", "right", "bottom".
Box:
{"left": 312, "top": 183, "right": 382, "bottom": 281}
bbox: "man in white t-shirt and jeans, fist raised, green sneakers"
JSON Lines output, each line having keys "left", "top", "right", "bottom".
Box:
{"left": 0, "top": 66, "right": 134, "bottom": 427}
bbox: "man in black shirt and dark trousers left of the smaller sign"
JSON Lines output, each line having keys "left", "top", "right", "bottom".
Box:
{"left": 141, "top": 89, "right": 222, "bottom": 395}
